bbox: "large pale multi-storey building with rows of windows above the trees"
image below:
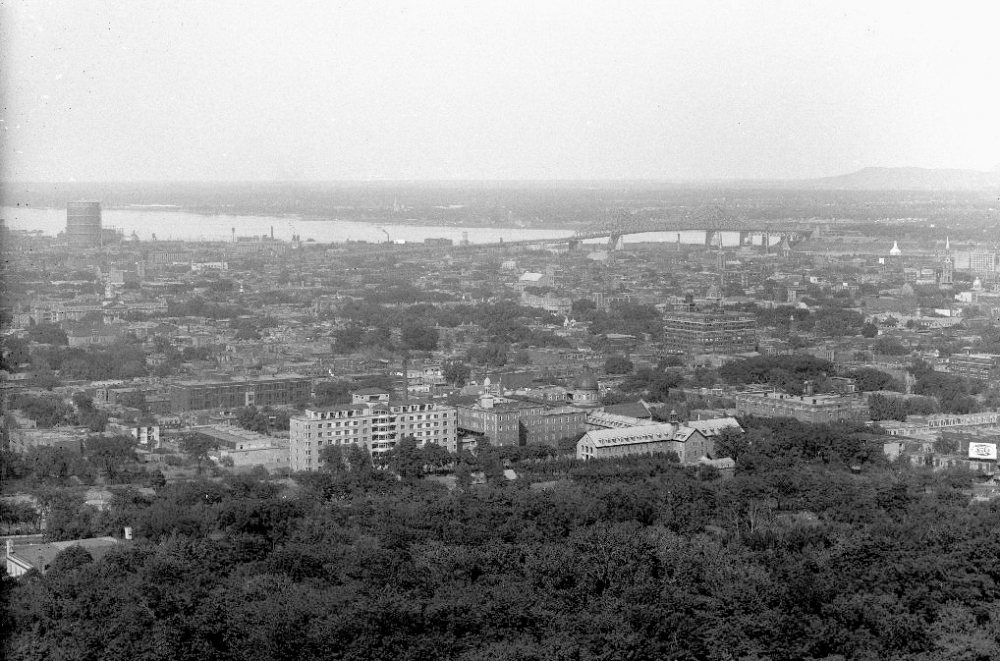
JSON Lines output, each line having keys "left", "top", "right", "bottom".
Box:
{"left": 289, "top": 397, "right": 458, "bottom": 471}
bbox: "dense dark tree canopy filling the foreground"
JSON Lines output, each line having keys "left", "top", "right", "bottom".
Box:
{"left": 0, "top": 419, "right": 1000, "bottom": 661}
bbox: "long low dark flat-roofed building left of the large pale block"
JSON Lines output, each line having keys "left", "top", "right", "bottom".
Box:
{"left": 169, "top": 374, "right": 312, "bottom": 413}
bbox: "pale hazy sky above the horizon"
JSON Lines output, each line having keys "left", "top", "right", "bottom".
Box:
{"left": 0, "top": 0, "right": 1000, "bottom": 181}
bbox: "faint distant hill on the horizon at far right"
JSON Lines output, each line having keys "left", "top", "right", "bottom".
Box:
{"left": 783, "top": 168, "right": 1000, "bottom": 190}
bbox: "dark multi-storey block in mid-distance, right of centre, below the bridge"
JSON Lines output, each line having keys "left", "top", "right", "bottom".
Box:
{"left": 663, "top": 310, "right": 757, "bottom": 354}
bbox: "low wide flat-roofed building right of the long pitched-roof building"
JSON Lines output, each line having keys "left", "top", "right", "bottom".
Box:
{"left": 736, "top": 392, "right": 868, "bottom": 423}
